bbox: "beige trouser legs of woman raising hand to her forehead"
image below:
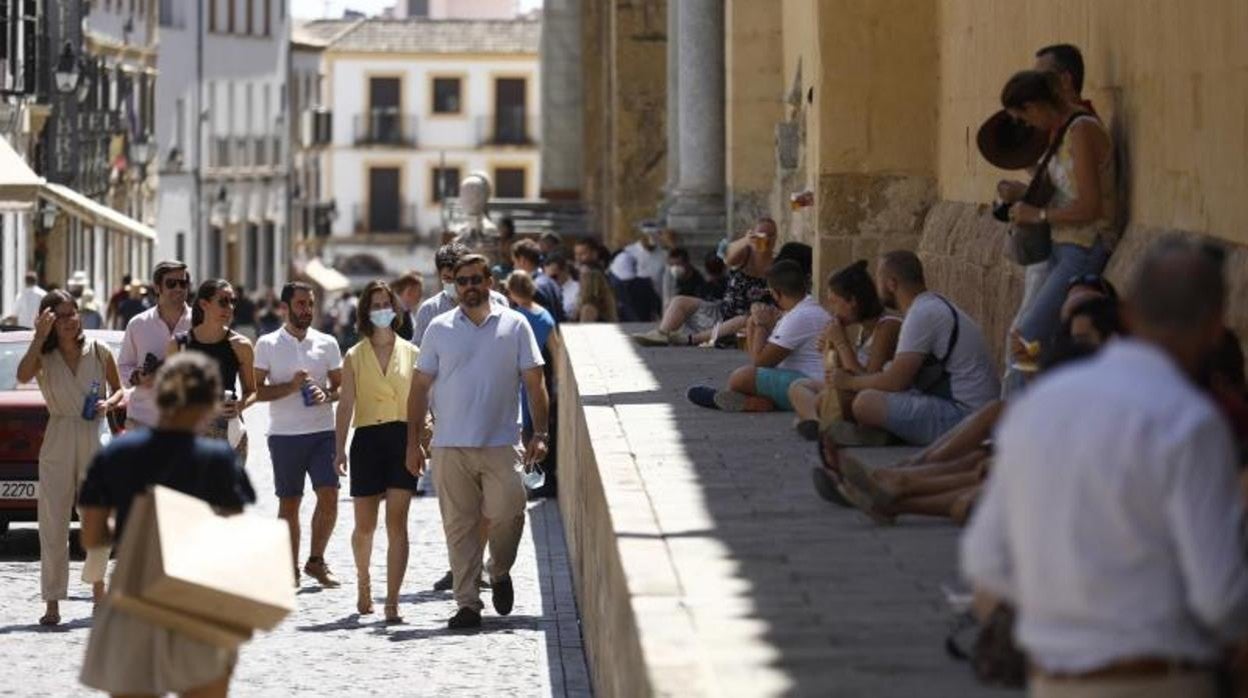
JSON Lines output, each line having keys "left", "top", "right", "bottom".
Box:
{"left": 37, "top": 416, "right": 100, "bottom": 601}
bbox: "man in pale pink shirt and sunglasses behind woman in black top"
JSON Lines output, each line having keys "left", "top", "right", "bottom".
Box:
{"left": 117, "top": 261, "right": 191, "bottom": 431}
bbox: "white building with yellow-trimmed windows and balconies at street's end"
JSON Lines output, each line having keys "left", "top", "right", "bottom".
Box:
{"left": 307, "top": 19, "right": 542, "bottom": 273}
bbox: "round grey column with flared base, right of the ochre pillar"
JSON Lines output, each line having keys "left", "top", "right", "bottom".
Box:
{"left": 668, "top": 0, "right": 725, "bottom": 248}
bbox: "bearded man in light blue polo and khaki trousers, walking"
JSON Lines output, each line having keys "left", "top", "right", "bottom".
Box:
{"left": 407, "top": 255, "right": 549, "bottom": 629}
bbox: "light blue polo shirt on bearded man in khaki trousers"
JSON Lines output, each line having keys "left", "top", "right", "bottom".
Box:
{"left": 416, "top": 303, "right": 544, "bottom": 448}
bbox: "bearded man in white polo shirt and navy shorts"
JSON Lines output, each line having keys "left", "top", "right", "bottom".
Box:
{"left": 256, "top": 282, "right": 342, "bottom": 588}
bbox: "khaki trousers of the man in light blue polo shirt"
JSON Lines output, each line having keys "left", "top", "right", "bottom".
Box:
{"left": 433, "top": 446, "right": 525, "bottom": 611}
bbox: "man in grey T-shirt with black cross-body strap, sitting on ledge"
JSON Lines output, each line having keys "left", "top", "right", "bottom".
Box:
{"left": 830, "top": 250, "right": 1000, "bottom": 446}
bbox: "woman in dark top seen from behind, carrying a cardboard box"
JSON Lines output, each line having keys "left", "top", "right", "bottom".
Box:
{"left": 79, "top": 352, "right": 256, "bottom": 696}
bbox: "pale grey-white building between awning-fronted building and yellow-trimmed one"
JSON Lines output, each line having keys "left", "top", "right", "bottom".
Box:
{"left": 156, "top": 0, "right": 291, "bottom": 290}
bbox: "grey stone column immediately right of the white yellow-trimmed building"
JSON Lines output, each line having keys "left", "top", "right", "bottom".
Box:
{"left": 540, "top": 0, "right": 584, "bottom": 200}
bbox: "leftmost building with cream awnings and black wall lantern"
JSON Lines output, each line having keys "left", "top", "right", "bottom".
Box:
{"left": 0, "top": 0, "right": 158, "bottom": 317}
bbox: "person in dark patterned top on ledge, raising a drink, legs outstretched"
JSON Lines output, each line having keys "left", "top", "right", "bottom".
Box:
{"left": 633, "top": 217, "right": 776, "bottom": 347}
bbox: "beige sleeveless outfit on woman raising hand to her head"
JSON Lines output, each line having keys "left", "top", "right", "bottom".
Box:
{"left": 37, "top": 340, "right": 110, "bottom": 601}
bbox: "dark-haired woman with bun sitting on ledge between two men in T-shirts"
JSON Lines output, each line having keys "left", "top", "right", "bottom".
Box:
{"left": 789, "top": 260, "right": 901, "bottom": 441}
